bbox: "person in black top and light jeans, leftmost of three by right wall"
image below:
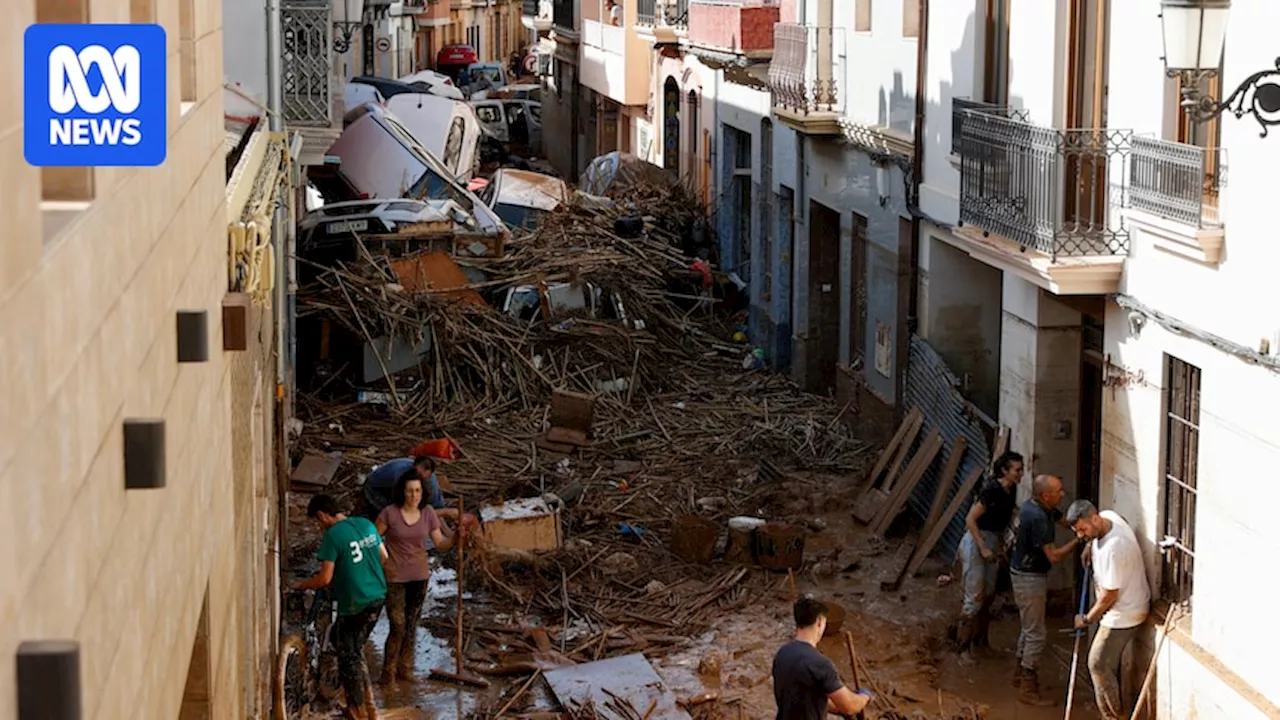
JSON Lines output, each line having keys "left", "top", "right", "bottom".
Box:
{"left": 956, "top": 452, "right": 1023, "bottom": 665}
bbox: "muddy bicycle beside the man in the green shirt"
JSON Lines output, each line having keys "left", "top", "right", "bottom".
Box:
{"left": 273, "top": 589, "right": 340, "bottom": 720}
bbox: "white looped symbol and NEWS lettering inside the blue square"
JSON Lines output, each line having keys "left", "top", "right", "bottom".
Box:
{"left": 49, "top": 45, "right": 142, "bottom": 145}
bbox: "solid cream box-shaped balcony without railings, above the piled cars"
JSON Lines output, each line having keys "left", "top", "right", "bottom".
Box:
{"left": 579, "top": 18, "right": 653, "bottom": 105}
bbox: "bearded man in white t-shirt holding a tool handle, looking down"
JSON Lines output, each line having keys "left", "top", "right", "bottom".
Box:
{"left": 1066, "top": 500, "right": 1151, "bottom": 720}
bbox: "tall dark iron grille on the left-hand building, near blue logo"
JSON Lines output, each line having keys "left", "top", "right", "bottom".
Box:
{"left": 280, "top": 1, "right": 333, "bottom": 127}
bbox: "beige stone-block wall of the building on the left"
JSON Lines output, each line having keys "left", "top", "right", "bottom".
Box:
{"left": 0, "top": 0, "right": 275, "bottom": 720}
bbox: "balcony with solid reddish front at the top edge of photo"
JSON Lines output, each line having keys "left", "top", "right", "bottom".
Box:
{"left": 689, "top": 0, "right": 781, "bottom": 60}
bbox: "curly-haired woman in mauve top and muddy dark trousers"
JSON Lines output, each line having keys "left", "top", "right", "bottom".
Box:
{"left": 374, "top": 468, "right": 457, "bottom": 684}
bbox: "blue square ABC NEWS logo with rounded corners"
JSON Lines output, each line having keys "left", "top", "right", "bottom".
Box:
{"left": 24, "top": 23, "right": 169, "bottom": 167}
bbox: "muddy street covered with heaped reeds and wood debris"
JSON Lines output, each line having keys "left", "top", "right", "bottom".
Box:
{"left": 287, "top": 184, "right": 1089, "bottom": 720}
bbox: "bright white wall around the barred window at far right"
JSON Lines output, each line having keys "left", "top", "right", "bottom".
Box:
{"left": 1102, "top": 0, "right": 1280, "bottom": 719}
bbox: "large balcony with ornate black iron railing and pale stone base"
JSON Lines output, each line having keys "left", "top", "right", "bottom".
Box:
{"left": 952, "top": 105, "right": 1132, "bottom": 295}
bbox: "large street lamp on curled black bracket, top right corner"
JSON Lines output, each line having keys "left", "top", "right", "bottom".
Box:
{"left": 1160, "top": 0, "right": 1280, "bottom": 137}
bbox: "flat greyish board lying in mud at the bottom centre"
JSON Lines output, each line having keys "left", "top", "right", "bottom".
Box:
{"left": 543, "top": 652, "right": 690, "bottom": 720}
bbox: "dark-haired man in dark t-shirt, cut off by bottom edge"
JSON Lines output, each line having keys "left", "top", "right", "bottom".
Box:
{"left": 773, "top": 596, "right": 872, "bottom": 720}
